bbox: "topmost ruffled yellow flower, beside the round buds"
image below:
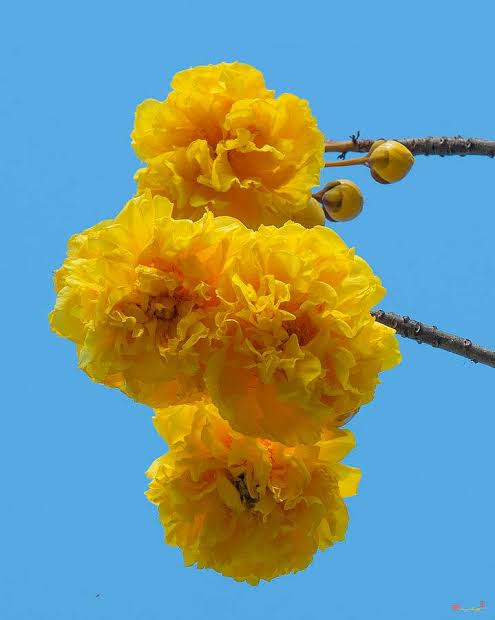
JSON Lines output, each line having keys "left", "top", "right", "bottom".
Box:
{"left": 132, "top": 62, "right": 324, "bottom": 229}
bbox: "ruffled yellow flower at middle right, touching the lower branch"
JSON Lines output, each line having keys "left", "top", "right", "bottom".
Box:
{"left": 205, "top": 222, "right": 400, "bottom": 445}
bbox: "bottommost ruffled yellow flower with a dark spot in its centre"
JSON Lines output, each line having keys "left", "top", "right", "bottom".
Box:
{"left": 146, "top": 400, "right": 360, "bottom": 585}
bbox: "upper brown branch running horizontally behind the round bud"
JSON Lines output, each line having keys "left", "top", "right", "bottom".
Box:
{"left": 325, "top": 136, "right": 495, "bottom": 159}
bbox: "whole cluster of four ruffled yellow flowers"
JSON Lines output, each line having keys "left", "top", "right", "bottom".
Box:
{"left": 50, "top": 63, "right": 400, "bottom": 584}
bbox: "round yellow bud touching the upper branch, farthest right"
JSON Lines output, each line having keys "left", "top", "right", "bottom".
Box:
{"left": 368, "top": 140, "right": 414, "bottom": 183}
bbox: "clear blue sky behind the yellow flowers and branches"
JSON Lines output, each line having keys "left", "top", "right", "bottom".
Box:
{"left": 0, "top": 0, "right": 495, "bottom": 620}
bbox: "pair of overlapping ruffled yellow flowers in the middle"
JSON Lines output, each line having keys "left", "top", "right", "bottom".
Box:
{"left": 50, "top": 192, "right": 399, "bottom": 445}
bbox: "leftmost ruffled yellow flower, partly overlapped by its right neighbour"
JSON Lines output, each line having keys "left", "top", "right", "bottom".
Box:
{"left": 50, "top": 192, "right": 248, "bottom": 405}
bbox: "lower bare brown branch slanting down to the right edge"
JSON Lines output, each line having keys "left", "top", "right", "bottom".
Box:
{"left": 371, "top": 310, "right": 495, "bottom": 368}
